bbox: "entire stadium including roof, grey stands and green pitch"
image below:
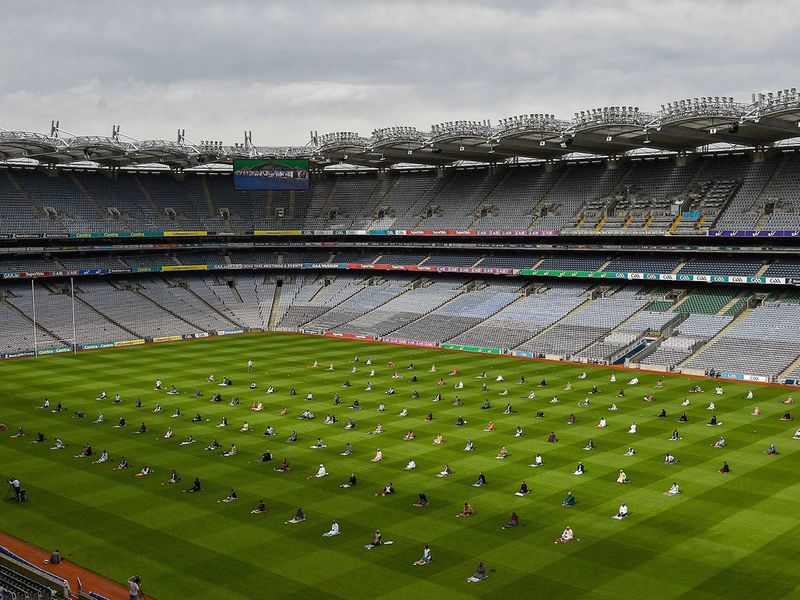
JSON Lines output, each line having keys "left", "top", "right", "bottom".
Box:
{"left": 0, "top": 2, "right": 800, "bottom": 600}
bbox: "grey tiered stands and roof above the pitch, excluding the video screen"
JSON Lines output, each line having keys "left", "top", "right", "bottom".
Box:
{"left": 0, "top": 89, "right": 800, "bottom": 383}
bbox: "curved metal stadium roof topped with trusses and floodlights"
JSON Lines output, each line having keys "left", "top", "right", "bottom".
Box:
{"left": 0, "top": 88, "right": 800, "bottom": 169}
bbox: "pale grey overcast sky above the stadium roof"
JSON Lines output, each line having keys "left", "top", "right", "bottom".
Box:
{"left": 0, "top": 0, "right": 800, "bottom": 145}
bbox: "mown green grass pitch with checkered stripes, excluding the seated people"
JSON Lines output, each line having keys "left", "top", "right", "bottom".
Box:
{"left": 0, "top": 334, "right": 800, "bottom": 599}
